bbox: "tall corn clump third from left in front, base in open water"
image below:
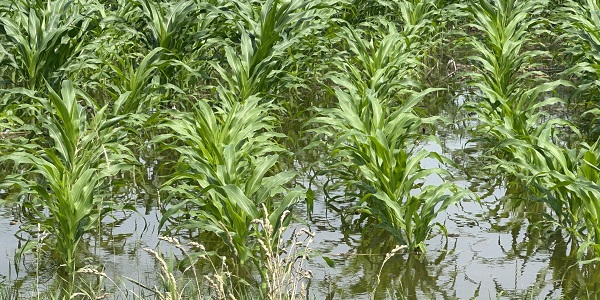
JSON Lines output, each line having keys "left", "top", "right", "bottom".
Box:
{"left": 315, "top": 19, "right": 466, "bottom": 252}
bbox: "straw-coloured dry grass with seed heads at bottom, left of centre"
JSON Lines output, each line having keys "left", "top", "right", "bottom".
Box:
{"left": 120, "top": 207, "right": 314, "bottom": 300}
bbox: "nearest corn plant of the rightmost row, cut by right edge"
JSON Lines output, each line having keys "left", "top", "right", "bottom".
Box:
{"left": 496, "top": 136, "right": 600, "bottom": 255}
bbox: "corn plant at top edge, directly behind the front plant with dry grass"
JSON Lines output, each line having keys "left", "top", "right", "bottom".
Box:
{"left": 212, "top": 0, "right": 320, "bottom": 100}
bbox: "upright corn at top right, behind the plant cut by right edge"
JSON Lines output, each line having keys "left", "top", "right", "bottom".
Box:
{"left": 465, "top": 0, "right": 573, "bottom": 164}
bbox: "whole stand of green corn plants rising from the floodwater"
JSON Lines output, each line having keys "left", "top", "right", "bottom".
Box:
{"left": 0, "top": 0, "right": 600, "bottom": 299}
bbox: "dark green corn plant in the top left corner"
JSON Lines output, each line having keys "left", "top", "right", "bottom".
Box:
{"left": 0, "top": 0, "right": 98, "bottom": 90}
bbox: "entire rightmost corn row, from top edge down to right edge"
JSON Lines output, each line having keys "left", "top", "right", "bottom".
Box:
{"left": 468, "top": 0, "right": 598, "bottom": 258}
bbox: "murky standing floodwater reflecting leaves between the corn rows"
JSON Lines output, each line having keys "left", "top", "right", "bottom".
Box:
{"left": 0, "top": 95, "right": 600, "bottom": 299}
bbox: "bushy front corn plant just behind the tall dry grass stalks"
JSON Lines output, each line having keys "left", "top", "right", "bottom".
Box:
{"left": 159, "top": 97, "right": 303, "bottom": 265}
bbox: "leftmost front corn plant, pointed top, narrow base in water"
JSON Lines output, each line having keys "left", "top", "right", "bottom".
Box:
{"left": 2, "top": 81, "right": 132, "bottom": 272}
